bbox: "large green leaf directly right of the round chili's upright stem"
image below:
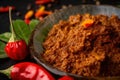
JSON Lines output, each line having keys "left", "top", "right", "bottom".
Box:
{"left": 13, "top": 20, "right": 31, "bottom": 44}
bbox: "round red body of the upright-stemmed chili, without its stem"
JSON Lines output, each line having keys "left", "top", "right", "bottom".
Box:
{"left": 5, "top": 40, "right": 28, "bottom": 60}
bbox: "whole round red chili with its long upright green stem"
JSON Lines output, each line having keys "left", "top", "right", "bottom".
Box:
{"left": 5, "top": 8, "right": 28, "bottom": 60}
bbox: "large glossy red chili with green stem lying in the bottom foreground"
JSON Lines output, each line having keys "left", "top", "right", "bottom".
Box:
{"left": 1, "top": 62, "right": 55, "bottom": 80}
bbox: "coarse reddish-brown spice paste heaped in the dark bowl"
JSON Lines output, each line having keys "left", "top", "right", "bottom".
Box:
{"left": 42, "top": 14, "right": 120, "bottom": 76}
